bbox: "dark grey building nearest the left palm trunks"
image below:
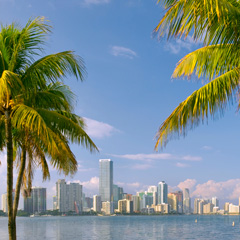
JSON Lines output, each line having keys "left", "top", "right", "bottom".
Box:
{"left": 24, "top": 187, "right": 47, "bottom": 214}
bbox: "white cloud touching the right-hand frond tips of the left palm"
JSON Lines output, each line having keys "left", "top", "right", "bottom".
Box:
{"left": 84, "top": 118, "right": 120, "bottom": 139}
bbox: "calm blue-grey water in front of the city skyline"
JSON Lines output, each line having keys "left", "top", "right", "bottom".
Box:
{"left": 0, "top": 216, "right": 240, "bottom": 240}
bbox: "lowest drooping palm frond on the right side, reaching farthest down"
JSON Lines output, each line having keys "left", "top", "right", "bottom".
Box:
{"left": 155, "top": 68, "right": 240, "bottom": 150}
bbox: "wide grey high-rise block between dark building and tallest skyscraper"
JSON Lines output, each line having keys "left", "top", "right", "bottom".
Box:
{"left": 55, "top": 179, "right": 83, "bottom": 214}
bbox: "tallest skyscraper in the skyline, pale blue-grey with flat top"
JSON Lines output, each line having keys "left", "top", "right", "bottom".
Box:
{"left": 99, "top": 159, "right": 113, "bottom": 202}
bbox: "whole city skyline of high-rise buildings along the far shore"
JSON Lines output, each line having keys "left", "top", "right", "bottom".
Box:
{"left": 1, "top": 159, "right": 240, "bottom": 215}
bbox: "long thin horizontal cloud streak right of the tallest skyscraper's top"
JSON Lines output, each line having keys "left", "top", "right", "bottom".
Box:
{"left": 111, "top": 153, "right": 202, "bottom": 162}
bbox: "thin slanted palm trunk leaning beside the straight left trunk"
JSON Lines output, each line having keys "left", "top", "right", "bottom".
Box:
{"left": 13, "top": 146, "right": 26, "bottom": 220}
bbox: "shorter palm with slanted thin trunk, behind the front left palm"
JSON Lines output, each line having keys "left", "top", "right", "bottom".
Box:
{"left": 12, "top": 82, "right": 97, "bottom": 221}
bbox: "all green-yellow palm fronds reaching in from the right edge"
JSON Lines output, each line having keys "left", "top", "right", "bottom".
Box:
{"left": 154, "top": 0, "right": 240, "bottom": 149}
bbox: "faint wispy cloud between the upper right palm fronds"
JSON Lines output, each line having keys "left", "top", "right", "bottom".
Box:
{"left": 165, "top": 36, "right": 196, "bottom": 54}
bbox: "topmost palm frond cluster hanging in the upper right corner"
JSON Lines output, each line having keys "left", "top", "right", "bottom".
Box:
{"left": 154, "top": 0, "right": 240, "bottom": 45}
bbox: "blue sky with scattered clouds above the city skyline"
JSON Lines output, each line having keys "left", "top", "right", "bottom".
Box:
{"left": 0, "top": 0, "right": 240, "bottom": 208}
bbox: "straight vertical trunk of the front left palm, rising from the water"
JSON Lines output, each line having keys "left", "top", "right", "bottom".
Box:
{"left": 5, "top": 109, "right": 16, "bottom": 240}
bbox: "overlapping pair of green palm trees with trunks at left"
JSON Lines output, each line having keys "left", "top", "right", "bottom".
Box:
{"left": 0, "top": 17, "right": 98, "bottom": 240}
